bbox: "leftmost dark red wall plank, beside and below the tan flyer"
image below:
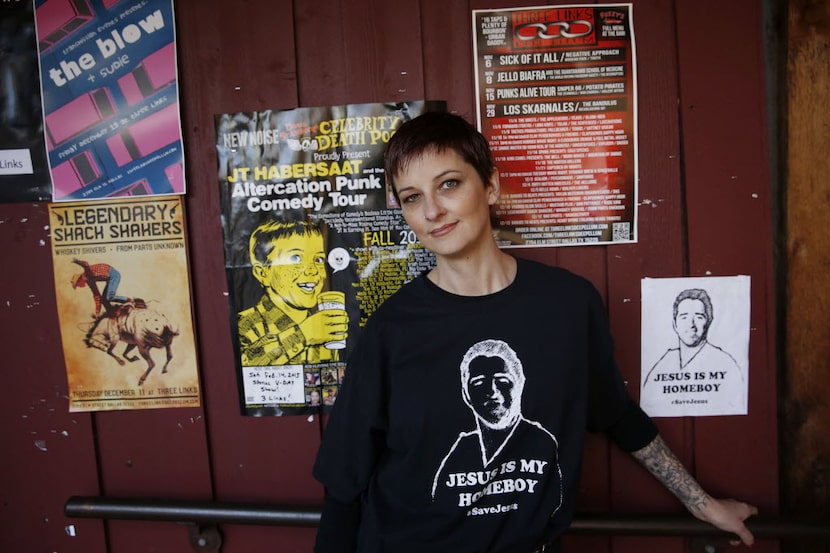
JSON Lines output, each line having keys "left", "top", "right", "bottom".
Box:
{"left": 0, "top": 203, "right": 105, "bottom": 551}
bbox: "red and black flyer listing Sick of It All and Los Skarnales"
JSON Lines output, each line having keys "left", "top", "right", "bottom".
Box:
{"left": 473, "top": 4, "right": 637, "bottom": 247}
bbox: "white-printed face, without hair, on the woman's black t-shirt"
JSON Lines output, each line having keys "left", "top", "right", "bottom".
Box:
{"left": 467, "top": 357, "right": 515, "bottom": 425}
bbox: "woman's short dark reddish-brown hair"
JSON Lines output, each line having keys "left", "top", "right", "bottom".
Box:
{"left": 383, "top": 111, "right": 496, "bottom": 198}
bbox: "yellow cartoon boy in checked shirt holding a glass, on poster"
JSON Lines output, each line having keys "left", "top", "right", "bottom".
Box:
{"left": 238, "top": 221, "right": 349, "bottom": 366}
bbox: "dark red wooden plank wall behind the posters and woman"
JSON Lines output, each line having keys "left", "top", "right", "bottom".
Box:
{"left": 0, "top": 0, "right": 778, "bottom": 553}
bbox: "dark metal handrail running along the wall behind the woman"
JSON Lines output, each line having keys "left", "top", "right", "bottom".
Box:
{"left": 64, "top": 496, "right": 830, "bottom": 539}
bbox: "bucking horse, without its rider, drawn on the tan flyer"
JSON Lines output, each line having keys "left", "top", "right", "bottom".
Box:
{"left": 84, "top": 300, "right": 179, "bottom": 386}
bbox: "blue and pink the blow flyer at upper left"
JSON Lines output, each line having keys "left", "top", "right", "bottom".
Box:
{"left": 35, "top": 0, "right": 185, "bottom": 202}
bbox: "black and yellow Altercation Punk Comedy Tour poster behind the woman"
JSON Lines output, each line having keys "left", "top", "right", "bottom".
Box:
{"left": 215, "top": 101, "right": 446, "bottom": 416}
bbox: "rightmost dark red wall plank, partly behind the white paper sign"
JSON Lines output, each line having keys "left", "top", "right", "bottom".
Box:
{"left": 677, "top": 0, "right": 778, "bottom": 551}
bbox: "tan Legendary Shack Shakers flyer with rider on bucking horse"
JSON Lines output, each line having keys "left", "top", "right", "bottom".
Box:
{"left": 49, "top": 196, "right": 200, "bottom": 411}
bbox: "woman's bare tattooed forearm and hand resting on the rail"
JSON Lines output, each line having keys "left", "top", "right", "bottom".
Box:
{"left": 631, "top": 435, "right": 758, "bottom": 545}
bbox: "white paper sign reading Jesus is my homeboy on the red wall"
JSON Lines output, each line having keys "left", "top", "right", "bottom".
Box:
{"left": 640, "top": 275, "right": 750, "bottom": 417}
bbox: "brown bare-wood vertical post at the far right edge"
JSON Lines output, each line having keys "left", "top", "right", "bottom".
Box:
{"left": 781, "top": 0, "right": 830, "bottom": 553}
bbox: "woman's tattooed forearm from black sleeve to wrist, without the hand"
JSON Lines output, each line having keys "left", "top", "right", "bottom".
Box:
{"left": 632, "top": 436, "right": 711, "bottom": 515}
